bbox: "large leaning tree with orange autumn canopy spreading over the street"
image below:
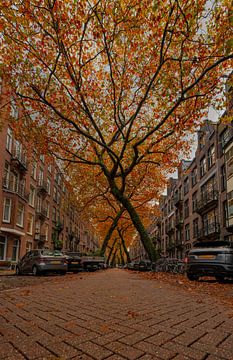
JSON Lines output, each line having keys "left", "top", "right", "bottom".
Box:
{"left": 0, "top": 0, "right": 233, "bottom": 259}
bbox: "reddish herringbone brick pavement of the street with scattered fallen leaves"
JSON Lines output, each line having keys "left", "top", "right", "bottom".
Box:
{"left": 0, "top": 269, "right": 233, "bottom": 360}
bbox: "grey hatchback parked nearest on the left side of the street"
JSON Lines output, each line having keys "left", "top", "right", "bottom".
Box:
{"left": 16, "top": 249, "right": 67, "bottom": 275}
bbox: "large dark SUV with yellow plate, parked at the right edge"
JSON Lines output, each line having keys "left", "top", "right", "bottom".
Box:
{"left": 186, "top": 241, "right": 233, "bottom": 282}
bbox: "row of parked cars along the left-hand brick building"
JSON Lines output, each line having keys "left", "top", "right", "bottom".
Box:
{"left": 16, "top": 249, "right": 105, "bottom": 275}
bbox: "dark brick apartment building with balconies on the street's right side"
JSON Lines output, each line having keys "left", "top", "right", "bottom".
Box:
{"left": 157, "top": 121, "right": 233, "bottom": 258}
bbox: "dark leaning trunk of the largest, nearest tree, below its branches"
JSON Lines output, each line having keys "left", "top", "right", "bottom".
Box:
{"left": 109, "top": 184, "right": 158, "bottom": 261}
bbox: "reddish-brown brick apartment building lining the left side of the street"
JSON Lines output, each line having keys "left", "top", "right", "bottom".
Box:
{"left": 0, "top": 88, "right": 98, "bottom": 266}
